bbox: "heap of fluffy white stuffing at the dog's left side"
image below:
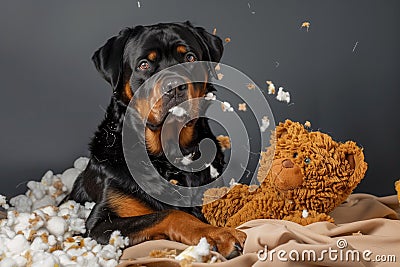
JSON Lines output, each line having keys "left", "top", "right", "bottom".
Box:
{"left": 0, "top": 158, "right": 128, "bottom": 267}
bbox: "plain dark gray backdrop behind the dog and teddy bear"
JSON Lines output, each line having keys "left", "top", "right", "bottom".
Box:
{"left": 0, "top": 0, "right": 400, "bottom": 196}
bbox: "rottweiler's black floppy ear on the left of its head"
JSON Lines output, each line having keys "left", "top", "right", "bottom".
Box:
{"left": 92, "top": 28, "right": 134, "bottom": 90}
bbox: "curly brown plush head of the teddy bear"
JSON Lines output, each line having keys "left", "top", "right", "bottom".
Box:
{"left": 258, "top": 120, "right": 367, "bottom": 213}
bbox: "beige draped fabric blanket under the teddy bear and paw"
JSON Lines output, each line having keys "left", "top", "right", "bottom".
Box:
{"left": 119, "top": 194, "right": 400, "bottom": 267}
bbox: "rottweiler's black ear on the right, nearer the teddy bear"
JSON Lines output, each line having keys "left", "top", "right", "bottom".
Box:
{"left": 195, "top": 27, "right": 224, "bottom": 62}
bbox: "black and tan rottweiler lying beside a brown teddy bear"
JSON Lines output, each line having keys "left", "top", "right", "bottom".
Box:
{"left": 66, "top": 22, "right": 246, "bottom": 258}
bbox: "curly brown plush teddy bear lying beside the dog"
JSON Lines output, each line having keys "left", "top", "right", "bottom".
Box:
{"left": 202, "top": 120, "right": 367, "bottom": 227}
